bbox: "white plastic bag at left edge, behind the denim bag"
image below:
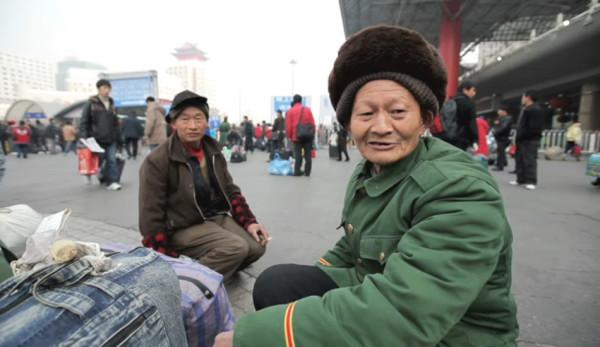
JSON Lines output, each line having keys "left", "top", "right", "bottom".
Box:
{"left": 0, "top": 205, "right": 44, "bottom": 258}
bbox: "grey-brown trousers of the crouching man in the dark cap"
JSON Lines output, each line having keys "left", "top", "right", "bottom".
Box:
{"left": 169, "top": 216, "right": 265, "bottom": 280}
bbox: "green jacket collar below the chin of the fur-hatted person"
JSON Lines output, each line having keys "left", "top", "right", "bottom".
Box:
{"left": 356, "top": 140, "right": 426, "bottom": 198}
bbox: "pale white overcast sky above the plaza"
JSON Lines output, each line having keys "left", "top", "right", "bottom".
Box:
{"left": 0, "top": 0, "right": 345, "bottom": 120}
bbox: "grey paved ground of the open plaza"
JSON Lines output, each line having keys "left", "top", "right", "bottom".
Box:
{"left": 0, "top": 151, "right": 600, "bottom": 346}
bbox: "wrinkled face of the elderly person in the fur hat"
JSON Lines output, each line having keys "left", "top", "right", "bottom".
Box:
{"left": 350, "top": 80, "right": 425, "bottom": 167}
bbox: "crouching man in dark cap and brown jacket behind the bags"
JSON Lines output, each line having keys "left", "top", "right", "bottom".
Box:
{"left": 139, "top": 90, "right": 269, "bottom": 279}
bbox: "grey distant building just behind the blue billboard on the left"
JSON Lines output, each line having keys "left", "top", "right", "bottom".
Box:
{"left": 56, "top": 58, "right": 106, "bottom": 94}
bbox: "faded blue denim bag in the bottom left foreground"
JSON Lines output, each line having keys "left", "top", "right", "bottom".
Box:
{"left": 0, "top": 248, "right": 186, "bottom": 347}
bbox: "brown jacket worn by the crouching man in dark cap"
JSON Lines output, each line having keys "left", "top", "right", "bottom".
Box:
{"left": 139, "top": 133, "right": 256, "bottom": 245}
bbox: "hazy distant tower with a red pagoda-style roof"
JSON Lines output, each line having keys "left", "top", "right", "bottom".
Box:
{"left": 166, "top": 43, "right": 216, "bottom": 103}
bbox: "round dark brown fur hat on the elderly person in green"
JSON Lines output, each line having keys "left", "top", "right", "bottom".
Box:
{"left": 329, "top": 25, "right": 448, "bottom": 127}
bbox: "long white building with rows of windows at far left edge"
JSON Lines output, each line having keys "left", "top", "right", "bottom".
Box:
{"left": 0, "top": 52, "right": 56, "bottom": 104}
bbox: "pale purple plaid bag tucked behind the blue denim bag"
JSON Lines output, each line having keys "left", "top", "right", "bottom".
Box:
{"left": 102, "top": 243, "right": 235, "bottom": 347}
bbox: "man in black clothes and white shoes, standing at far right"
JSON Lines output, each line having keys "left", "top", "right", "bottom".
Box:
{"left": 510, "top": 91, "right": 545, "bottom": 190}
